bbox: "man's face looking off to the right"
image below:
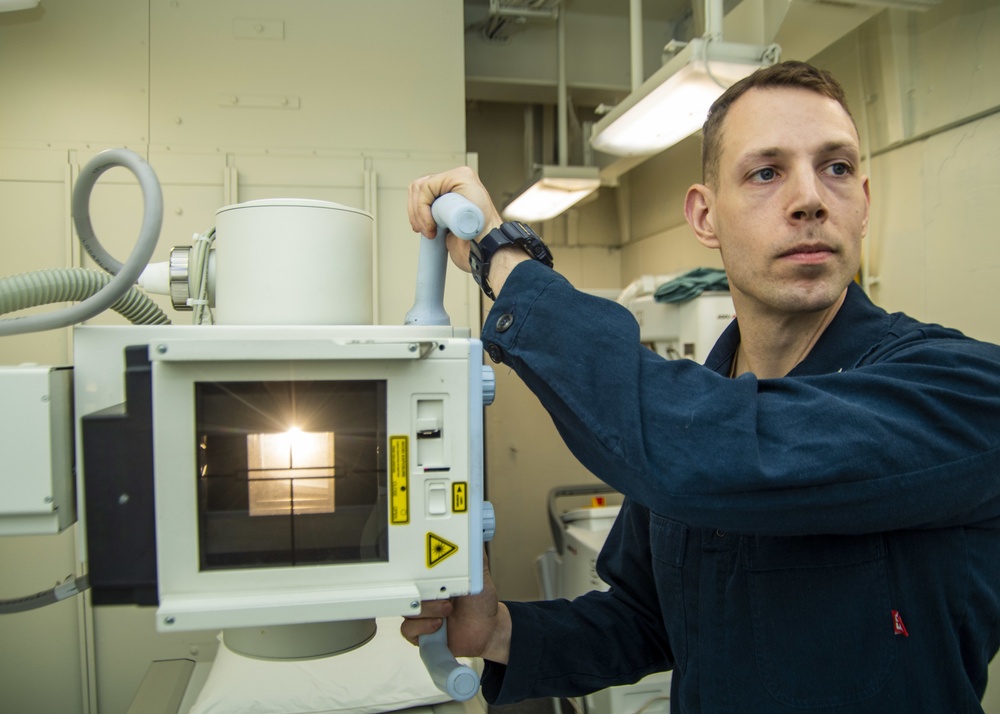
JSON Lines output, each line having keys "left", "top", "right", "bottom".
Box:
{"left": 689, "top": 88, "right": 869, "bottom": 315}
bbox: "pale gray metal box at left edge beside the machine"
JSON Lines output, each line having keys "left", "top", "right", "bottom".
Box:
{"left": 0, "top": 365, "right": 76, "bottom": 535}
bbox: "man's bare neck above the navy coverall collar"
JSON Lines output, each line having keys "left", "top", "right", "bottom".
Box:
{"left": 734, "top": 290, "right": 847, "bottom": 379}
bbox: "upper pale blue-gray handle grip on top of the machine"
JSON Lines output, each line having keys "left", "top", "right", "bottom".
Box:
{"left": 405, "top": 193, "right": 485, "bottom": 325}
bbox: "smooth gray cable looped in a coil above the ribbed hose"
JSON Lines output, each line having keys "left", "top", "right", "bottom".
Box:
{"left": 0, "top": 149, "right": 163, "bottom": 337}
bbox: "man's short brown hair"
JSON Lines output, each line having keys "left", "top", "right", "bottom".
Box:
{"left": 701, "top": 60, "right": 857, "bottom": 186}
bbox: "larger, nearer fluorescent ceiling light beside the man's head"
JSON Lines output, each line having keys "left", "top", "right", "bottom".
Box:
{"left": 590, "top": 38, "right": 777, "bottom": 156}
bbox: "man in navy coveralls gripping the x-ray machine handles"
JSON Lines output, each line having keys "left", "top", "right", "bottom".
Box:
{"left": 402, "top": 62, "right": 1000, "bottom": 714}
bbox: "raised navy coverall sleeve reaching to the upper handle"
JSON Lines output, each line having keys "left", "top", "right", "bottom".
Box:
{"left": 483, "top": 262, "right": 1000, "bottom": 535}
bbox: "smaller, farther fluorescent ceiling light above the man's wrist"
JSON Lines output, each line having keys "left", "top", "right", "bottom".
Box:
{"left": 501, "top": 166, "right": 601, "bottom": 223}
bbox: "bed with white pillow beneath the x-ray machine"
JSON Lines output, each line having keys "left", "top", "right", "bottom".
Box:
{"left": 127, "top": 618, "right": 487, "bottom": 714}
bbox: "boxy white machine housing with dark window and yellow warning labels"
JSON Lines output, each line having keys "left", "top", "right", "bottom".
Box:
{"left": 74, "top": 325, "right": 491, "bottom": 631}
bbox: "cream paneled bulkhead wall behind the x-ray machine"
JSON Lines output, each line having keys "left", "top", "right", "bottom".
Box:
{"left": 0, "top": 0, "right": 478, "bottom": 714}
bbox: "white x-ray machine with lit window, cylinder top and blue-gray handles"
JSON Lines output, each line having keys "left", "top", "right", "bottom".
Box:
{"left": 0, "top": 150, "right": 493, "bottom": 701}
